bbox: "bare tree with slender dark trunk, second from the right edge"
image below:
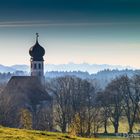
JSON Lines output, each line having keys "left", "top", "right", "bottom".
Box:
{"left": 105, "top": 78, "right": 123, "bottom": 133}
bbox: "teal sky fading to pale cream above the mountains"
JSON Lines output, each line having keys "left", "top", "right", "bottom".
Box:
{"left": 0, "top": 0, "right": 140, "bottom": 68}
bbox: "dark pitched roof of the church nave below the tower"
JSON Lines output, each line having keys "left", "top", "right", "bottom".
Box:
{"left": 0, "top": 76, "right": 52, "bottom": 109}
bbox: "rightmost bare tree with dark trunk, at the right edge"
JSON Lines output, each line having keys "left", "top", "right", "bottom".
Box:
{"left": 119, "top": 76, "right": 139, "bottom": 133}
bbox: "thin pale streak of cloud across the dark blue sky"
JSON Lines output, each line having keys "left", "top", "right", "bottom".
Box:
{"left": 0, "top": 20, "right": 140, "bottom": 27}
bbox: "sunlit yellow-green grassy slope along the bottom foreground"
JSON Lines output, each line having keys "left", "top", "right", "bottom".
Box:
{"left": 0, "top": 127, "right": 140, "bottom": 140}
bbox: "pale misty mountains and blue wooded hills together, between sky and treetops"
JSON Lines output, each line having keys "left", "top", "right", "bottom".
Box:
{"left": 0, "top": 63, "right": 140, "bottom": 88}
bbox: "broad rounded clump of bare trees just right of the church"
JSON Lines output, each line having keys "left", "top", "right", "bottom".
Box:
{"left": 48, "top": 76, "right": 95, "bottom": 136}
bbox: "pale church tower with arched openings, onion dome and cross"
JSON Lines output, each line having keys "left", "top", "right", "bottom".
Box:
{"left": 29, "top": 33, "right": 45, "bottom": 85}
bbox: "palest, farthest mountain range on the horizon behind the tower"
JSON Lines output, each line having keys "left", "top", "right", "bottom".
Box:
{"left": 0, "top": 63, "right": 135, "bottom": 74}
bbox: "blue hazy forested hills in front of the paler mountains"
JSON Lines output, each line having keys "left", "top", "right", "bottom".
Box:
{"left": 0, "top": 69, "right": 140, "bottom": 88}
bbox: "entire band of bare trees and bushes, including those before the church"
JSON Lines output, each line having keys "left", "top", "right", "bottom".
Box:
{"left": 0, "top": 75, "right": 140, "bottom": 136}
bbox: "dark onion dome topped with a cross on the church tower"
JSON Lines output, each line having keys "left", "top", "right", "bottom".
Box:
{"left": 29, "top": 33, "right": 45, "bottom": 61}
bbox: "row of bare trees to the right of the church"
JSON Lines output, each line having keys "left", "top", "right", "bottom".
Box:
{"left": 47, "top": 75, "right": 140, "bottom": 136}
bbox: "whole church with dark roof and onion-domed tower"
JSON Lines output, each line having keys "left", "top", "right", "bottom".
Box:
{"left": 0, "top": 33, "right": 52, "bottom": 130}
